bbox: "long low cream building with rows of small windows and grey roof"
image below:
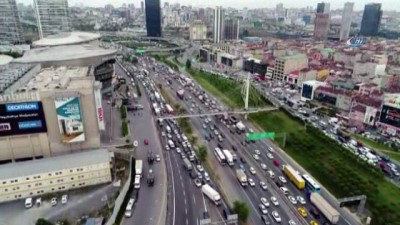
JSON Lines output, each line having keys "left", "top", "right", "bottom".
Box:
{"left": 0, "top": 149, "right": 112, "bottom": 202}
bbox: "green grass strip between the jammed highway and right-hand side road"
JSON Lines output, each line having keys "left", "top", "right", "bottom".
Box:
{"left": 188, "top": 67, "right": 400, "bottom": 225}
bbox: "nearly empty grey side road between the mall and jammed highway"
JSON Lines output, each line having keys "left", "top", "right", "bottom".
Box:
{"left": 115, "top": 63, "right": 167, "bottom": 225}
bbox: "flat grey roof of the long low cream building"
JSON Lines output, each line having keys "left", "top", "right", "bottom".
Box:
{"left": 0, "top": 149, "right": 111, "bottom": 180}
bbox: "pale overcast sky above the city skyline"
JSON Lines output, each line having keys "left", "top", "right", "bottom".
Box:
{"left": 17, "top": 0, "right": 400, "bottom": 11}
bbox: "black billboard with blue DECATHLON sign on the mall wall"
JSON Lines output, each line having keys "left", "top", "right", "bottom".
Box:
{"left": 0, "top": 101, "right": 47, "bottom": 137}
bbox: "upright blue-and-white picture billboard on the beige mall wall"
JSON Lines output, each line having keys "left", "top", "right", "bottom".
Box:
{"left": 54, "top": 97, "right": 85, "bottom": 143}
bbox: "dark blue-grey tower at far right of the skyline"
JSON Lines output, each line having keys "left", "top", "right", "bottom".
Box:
{"left": 360, "top": 3, "right": 382, "bottom": 36}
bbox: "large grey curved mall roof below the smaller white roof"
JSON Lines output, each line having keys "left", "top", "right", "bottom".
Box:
{"left": 13, "top": 44, "right": 116, "bottom": 63}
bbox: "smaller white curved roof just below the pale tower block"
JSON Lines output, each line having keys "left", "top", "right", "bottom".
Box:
{"left": 33, "top": 32, "right": 101, "bottom": 47}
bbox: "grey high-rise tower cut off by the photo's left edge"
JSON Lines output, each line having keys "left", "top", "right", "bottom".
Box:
{"left": 0, "top": 0, "right": 24, "bottom": 45}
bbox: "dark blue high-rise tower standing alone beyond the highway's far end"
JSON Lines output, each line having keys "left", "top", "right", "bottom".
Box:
{"left": 145, "top": 0, "right": 161, "bottom": 37}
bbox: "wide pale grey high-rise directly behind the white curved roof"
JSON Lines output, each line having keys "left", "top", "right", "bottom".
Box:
{"left": 33, "top": 0, "right": 70, "bottom": 39}
